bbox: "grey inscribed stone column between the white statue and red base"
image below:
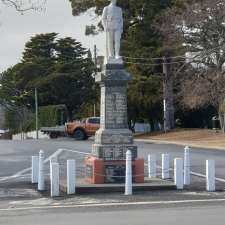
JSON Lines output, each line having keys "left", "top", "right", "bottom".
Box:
{"left": 92, "top": 64, "right": 137, "bottom": 160}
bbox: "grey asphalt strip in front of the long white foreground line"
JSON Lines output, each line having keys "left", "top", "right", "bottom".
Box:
{"left": 0, "top": 204, "right": 225, "bottom": 225}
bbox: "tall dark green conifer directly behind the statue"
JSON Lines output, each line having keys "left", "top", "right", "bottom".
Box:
{"left": 67, "top": 0, "right": 175, "bottom": 129}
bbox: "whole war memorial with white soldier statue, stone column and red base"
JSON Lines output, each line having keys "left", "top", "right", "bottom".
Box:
{"left": 85, "top": 0, "right": 144, "bottom": 184}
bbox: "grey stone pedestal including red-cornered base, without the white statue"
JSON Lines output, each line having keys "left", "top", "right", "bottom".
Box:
{"left": 86, "top": 64, "right": 144, "bottom": 183}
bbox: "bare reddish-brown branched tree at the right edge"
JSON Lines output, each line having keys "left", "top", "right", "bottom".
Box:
{"left": 163, "top": 0, "right": 225, "bottom": 126}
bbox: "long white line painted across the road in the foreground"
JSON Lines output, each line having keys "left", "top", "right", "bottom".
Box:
{"left": 0, "top": 199, "right": 225, "bottom": 212}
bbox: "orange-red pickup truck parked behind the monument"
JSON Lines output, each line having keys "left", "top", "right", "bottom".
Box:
{"left": 65, "top": 117, "right": 100, "bottom": 140}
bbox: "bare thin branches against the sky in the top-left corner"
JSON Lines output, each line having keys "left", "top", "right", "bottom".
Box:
{"left": 1, "top": 0, "right": 46, "bottom": 13}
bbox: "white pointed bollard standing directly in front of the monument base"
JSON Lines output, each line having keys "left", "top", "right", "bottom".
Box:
{"left": 125, "top": 150, "right": 132, "bottom": 195}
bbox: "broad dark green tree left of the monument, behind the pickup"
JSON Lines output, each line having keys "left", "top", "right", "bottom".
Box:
{"left": 0, "top": 33, "right": 95, "bottom": 132}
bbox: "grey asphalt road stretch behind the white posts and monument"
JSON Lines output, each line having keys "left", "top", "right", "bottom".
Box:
{"left": 0, "top": 138, "right": 225, "bottom": 179}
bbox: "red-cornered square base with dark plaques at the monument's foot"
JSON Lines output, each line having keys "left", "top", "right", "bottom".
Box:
{"left": 85, "top": 156, "right": 144, "bottom": 184}
